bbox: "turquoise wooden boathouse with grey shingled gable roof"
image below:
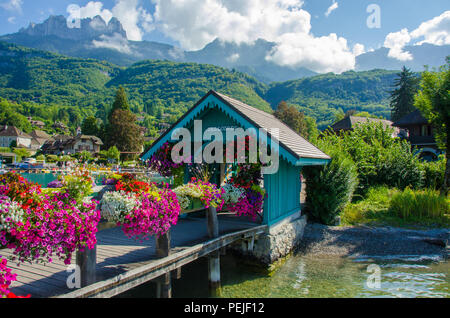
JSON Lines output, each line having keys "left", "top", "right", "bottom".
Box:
{"left": 141, "top": 91, "right": 331, "bottom": 226}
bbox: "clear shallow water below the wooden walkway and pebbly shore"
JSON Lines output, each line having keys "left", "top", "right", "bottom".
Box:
{"left": 120, "top": 251, "right": 450, "bottom": 298}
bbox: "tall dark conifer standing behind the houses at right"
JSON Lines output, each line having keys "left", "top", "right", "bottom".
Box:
{"left": 390, "top": 66, "right": 419, "bottom": 122}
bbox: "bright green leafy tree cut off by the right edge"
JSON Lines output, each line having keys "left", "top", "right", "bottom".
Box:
{"left": 414, "top": 56, "right": 450, "bottom": 195}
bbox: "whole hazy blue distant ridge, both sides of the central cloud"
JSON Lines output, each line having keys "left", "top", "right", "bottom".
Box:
{"left": 0, "top": 15, "right": 450, "bottom": 84}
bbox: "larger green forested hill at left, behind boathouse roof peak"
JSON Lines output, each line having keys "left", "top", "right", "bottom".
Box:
{"left": 0, "top": 42, "right": 271, "bottom": 134}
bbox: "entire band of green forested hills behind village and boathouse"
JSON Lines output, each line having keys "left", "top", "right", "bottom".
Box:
{"left": 0, "top": 42, "right": 404, "bottom": 135}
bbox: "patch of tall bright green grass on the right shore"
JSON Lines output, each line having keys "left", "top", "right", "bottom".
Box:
{"left": 341, "top": 187, "right": 450, "bottom": 228}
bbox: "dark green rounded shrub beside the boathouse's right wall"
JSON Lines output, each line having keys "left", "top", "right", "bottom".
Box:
{"left": 303, "top": 151, "right": 358, "bottom": 224}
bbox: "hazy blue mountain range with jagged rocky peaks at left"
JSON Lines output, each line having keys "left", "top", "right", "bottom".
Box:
{"left": 0, "top": 16, "right": 316, "bottom": 83}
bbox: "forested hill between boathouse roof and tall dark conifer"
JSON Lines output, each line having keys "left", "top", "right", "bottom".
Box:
{"left": 264, "top": 70, "right": 398, "bottom": 128}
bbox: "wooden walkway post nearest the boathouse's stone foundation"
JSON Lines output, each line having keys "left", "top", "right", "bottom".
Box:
{"left": 206, "top": 206, "right": 221, "bottom": 297}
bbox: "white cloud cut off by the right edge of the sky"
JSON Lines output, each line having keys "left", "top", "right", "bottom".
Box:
{"left": 384, "top": 11, "right": 450, "bottom": 61}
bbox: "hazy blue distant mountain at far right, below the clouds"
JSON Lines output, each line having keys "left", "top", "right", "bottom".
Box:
{"left": 356, "top": 43, "right": 450, "bottom": 72}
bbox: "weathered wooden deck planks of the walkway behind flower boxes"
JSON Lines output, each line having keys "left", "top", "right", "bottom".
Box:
{"left": 4, "top": 218, "right": 264, "bottom": 297}
